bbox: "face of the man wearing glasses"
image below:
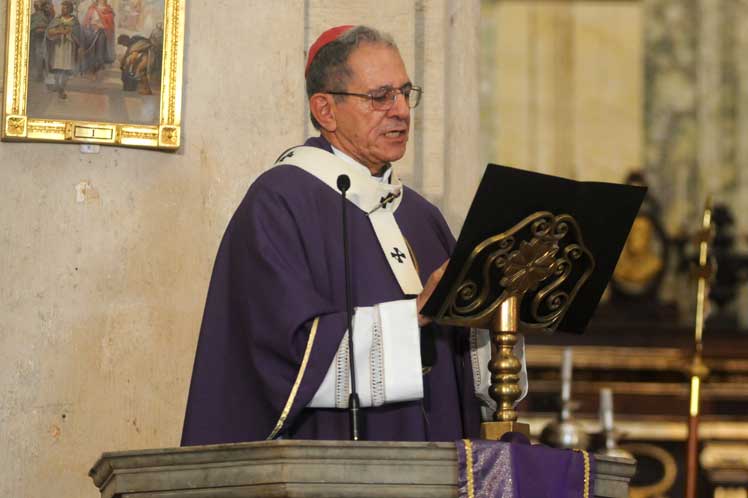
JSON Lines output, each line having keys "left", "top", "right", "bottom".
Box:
{"left": 333, "top": 44, "right": 410, "bottom": 172}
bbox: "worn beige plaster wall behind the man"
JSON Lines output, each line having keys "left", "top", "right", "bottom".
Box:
{"left": 0, "top": 0, "right": 482, "bottom": 497}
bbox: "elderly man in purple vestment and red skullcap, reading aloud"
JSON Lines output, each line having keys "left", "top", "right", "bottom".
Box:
{"left": 182, "top": 26, "right": 488, "bottom": 445}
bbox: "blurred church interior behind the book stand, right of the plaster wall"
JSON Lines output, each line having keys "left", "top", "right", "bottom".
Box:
{"left": 480, "top": 0, "right": 748, "bottom": 498}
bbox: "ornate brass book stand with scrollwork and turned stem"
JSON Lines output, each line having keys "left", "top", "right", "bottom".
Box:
{"left": 435, "top": 211, "right": 595, "bottom": 439}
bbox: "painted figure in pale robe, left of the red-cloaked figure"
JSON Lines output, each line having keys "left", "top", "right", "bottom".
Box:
{"left": 45, "top": 0, "right": 81, "bottom": 99}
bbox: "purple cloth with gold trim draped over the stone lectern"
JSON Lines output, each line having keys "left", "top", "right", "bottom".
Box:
{"left": 455, "top": 439, "right": 595, "bottom": 498}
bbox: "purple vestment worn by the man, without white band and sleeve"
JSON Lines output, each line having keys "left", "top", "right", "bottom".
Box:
{"left": 182, "top": 137, "right": 480, "bottom": 445}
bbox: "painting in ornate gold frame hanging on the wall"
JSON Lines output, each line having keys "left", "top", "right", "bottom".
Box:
{"left": 2, "top": 0, "right": 186, "bottom": 150}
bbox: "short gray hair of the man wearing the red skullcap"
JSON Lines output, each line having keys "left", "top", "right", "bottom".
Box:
{"left": 306, "top": 26, "right": 398, "bottom": 130}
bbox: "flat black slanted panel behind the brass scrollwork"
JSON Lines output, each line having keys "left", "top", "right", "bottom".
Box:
{"left": 421, "top": 164, "right": 647, "bottom": 333}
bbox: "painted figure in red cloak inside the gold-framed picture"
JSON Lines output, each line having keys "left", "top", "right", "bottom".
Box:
{"left": 81, "top": 0, "right": 114, "bottom": 75}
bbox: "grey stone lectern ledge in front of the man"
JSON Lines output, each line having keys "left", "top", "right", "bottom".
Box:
{"left": 90, "top": 440, "right": 635, "bottom": 498}
